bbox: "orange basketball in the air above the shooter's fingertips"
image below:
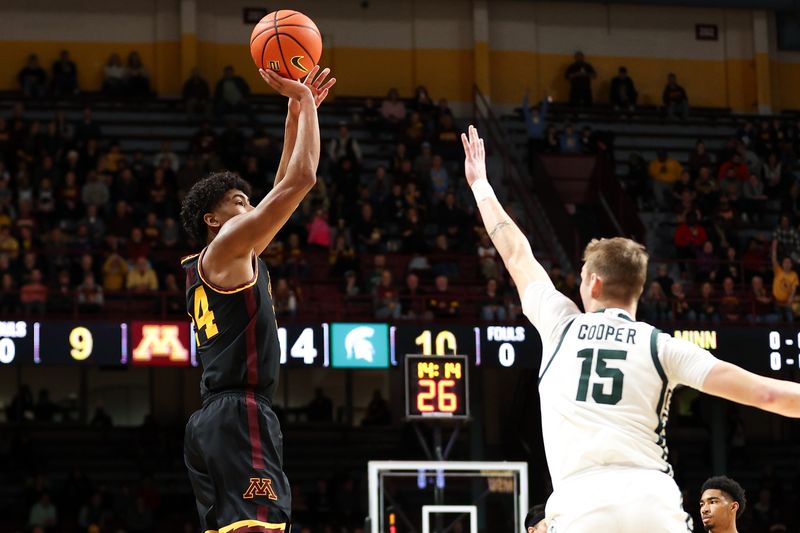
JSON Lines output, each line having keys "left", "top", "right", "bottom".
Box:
{"left": 250, "top": 9, "right": 322, "bottom": 80}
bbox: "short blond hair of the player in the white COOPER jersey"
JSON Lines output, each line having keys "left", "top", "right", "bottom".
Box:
{"left": 583, "top": 237, "right": 648, "bottom": 302}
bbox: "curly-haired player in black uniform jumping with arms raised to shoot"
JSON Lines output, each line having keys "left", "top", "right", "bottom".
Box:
{"left": 181, "top": 67, "right": 336, "bottom": 533}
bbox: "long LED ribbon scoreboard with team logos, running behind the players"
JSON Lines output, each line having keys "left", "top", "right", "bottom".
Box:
{"left": 0, "top": 320, "right": 800, "bottom": 380}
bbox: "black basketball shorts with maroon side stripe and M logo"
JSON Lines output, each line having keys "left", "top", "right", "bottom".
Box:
{"left": 183, "top": 391, "right": 292, "bottom": 533}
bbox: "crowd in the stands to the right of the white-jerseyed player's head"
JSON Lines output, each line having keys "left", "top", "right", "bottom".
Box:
{"left": 626, "top": 118, "right": 800, "bottom": 323}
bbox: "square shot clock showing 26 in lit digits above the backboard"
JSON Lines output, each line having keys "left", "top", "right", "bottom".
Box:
{"left": 405, "top": 355, "right": 469, "bottom": 420}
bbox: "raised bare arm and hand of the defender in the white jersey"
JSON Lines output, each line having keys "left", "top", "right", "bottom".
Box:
{"left": 461, "top": 126, "right": 552, "bottom": 298}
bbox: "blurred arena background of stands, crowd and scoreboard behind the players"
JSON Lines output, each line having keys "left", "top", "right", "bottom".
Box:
{"left": 0, "top": 0, "right": 800, "bottom": 533}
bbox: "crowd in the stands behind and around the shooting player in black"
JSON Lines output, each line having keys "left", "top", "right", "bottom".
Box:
{"left": 0, "top": 51, "right": 552, "bottom": 320}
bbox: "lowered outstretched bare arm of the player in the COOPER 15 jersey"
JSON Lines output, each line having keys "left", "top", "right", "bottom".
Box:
{"left": 701, "top": 361, "right": 800, "bottom": 418}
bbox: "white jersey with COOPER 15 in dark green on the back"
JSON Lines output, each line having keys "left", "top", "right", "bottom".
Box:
{"left": 522, "top": 282, "right": 717, "bottom": 493}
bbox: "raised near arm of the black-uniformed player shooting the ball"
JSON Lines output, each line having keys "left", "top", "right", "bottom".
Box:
{"left": 202, "top": 70, "right": 320, "bottom": 287}
